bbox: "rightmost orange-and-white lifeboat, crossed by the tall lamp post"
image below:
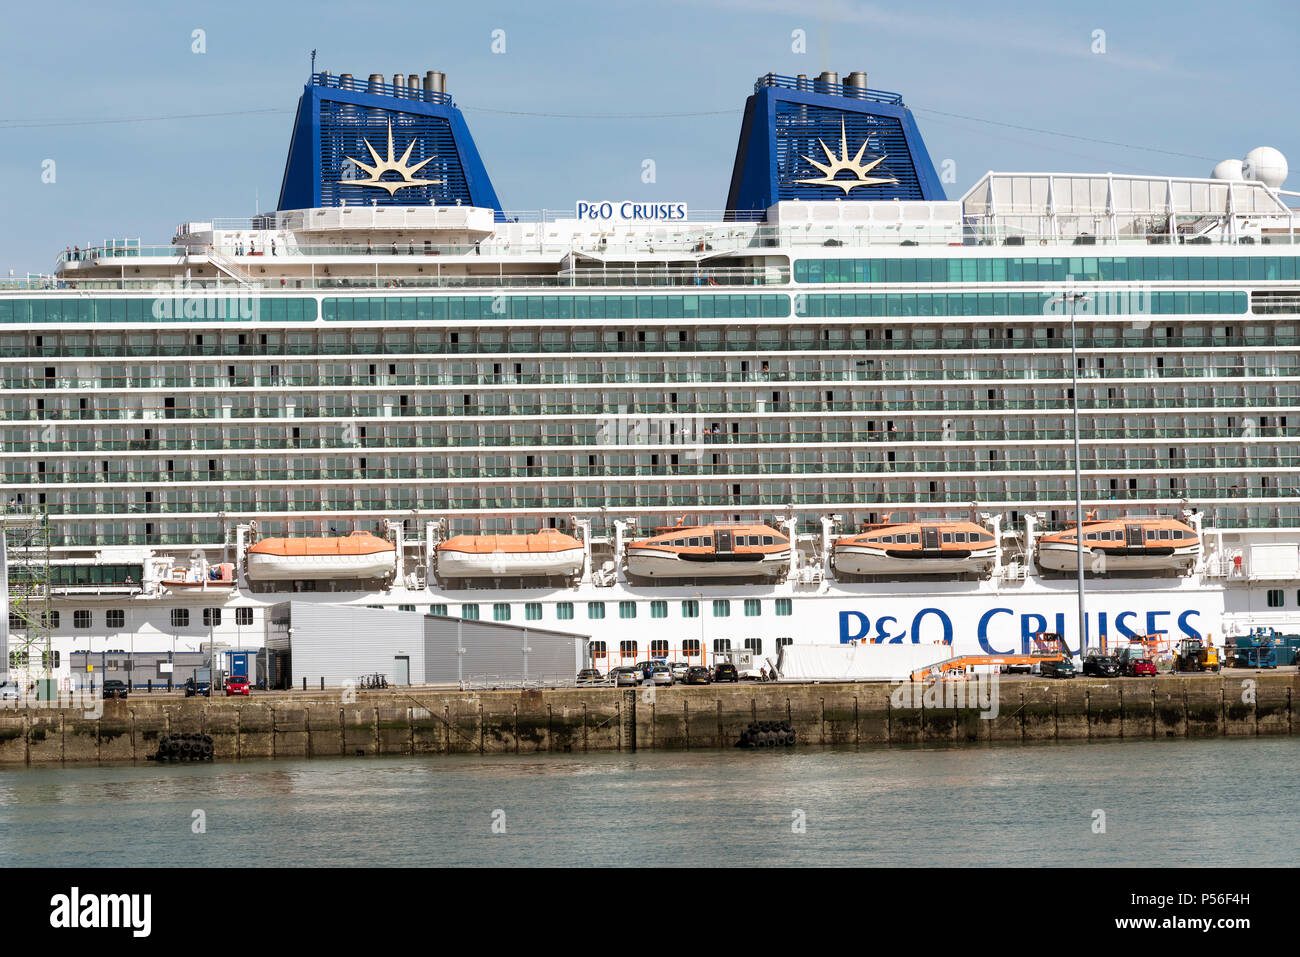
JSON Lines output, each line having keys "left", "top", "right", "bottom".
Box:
{"left": 1037, "top": 515, "right": 1201, "bottom": 573}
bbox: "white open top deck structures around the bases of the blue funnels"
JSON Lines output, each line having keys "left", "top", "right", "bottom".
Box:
{"left": 17, "top": 173, "right": 1300, "bottom": 297}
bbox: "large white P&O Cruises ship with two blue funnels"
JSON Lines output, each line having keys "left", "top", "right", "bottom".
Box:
{"left": 0, "top": 70, "right": 1300, "bottom": 683}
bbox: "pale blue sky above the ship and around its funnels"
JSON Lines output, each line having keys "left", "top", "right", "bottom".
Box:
{"left": 0, "top": 0, "right": 1300, "bottom": 276}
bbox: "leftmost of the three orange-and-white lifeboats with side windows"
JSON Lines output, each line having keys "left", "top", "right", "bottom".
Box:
{"left": 628, "top": 525, "right": 790, "bottom": 579}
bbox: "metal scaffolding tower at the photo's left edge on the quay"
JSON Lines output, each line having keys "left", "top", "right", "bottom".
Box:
{"left": 0, "top": 506, "right": 56, "bottom": 697}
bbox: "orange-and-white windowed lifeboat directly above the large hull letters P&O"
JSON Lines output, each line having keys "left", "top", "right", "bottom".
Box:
{"left": 832, "top": 516, "right": 997, "bottom": 575}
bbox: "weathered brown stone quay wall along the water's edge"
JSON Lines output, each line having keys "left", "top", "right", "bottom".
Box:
{"left": 0, "top": 672, "right": 1300, "bottom": 766}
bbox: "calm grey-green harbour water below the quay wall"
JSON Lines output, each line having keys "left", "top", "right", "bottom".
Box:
{"left": 0, "top": 739, "right": 1300, "bottom": 867}
